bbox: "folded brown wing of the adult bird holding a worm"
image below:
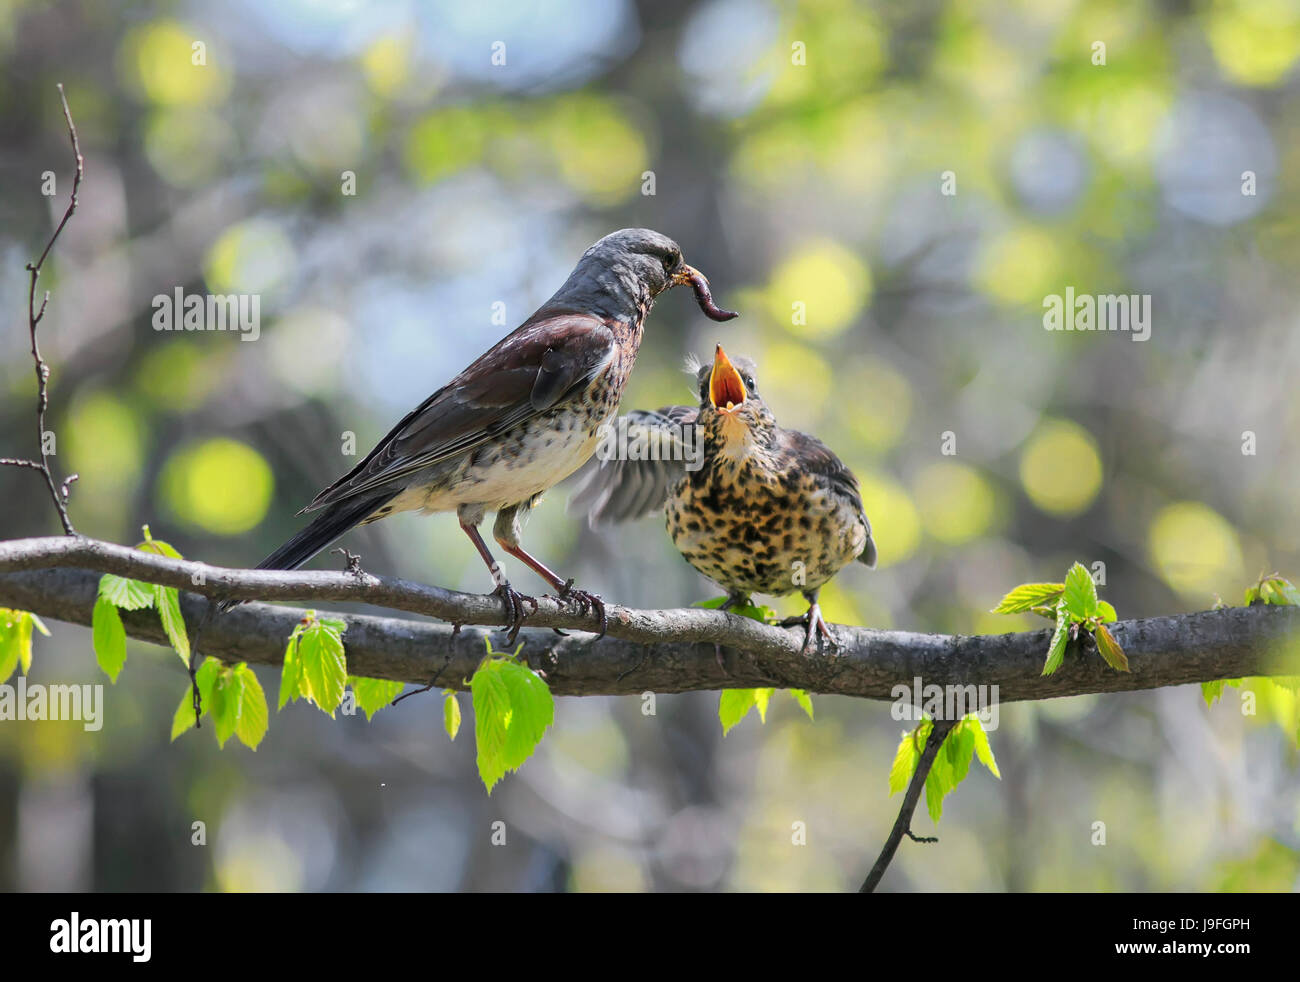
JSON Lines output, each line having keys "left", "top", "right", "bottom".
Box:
{"left": 299, "top": 313, "right": 615, "bottom": 514}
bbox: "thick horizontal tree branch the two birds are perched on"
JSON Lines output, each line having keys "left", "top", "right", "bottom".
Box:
{"left": 0, "top": 537, "right": 1300, "bottom": 702}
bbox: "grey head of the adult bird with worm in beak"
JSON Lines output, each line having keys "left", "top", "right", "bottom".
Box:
{"left": 546, "top": 229, "right": 736, "bottom": 321}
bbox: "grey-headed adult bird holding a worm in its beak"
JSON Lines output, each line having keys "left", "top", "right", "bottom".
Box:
{"left": 222, "top": 229, "right": 736, "bottom": 640}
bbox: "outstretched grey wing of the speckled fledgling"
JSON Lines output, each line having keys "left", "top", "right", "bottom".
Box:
{"left": 568, "top": 406, "right": 703, "bottom": 528}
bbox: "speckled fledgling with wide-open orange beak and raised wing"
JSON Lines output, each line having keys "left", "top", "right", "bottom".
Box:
{"left": 569, "top": 345, "right": 876, "bottom": 652}
